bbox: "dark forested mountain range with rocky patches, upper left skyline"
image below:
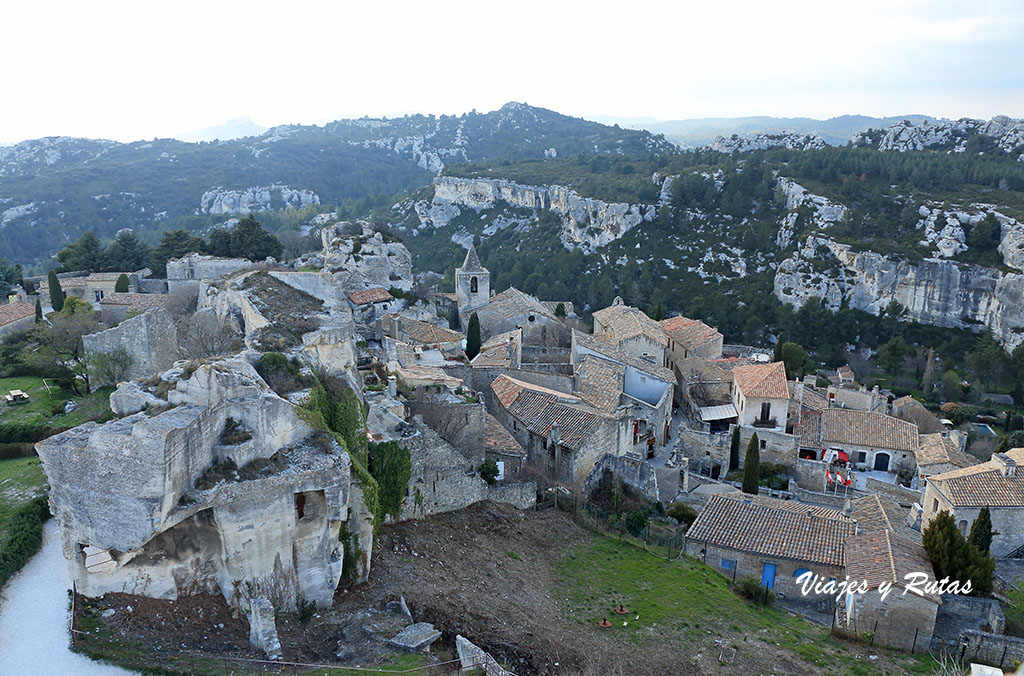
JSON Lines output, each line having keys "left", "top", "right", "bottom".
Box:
{"left": 0, "top": 102, "right": 676, "bottom": 263}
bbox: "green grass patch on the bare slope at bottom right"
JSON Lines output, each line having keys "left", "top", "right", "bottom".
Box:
{"left": 560, "top": 539, "right": 936, "bottom": 674}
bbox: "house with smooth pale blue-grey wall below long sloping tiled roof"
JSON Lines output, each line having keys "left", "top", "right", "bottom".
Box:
{"left": 570, "top": 330, "right": 676, "bottom": 446}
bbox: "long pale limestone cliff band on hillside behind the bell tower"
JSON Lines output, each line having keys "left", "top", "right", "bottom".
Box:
{"left": 415, "top": 176, "right": 657, "bottom": 253}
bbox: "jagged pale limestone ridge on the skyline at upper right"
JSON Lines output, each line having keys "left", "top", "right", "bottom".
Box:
{"left": 853, "top": 115, "right": 1024, "bottom": 162}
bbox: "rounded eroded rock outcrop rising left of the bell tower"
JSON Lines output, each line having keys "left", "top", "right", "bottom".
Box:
{"left": 321, "top": 221, "right": 414, "bottom": 291}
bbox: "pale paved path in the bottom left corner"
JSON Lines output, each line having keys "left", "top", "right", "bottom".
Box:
{"left": 0, "top": 519, "right": 134, "bottom": 676}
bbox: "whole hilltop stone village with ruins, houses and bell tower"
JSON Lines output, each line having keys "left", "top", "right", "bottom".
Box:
{"left": 6, "top": 222, "right": 1024, "bottom": 674}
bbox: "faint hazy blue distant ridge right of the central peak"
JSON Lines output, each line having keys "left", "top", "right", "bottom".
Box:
{"left": 591, "top": 115, "right": 939, "bottom": 147}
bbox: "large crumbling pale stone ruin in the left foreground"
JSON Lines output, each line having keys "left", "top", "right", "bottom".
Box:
{"left": 37, "top": 355, "right": 373, "bottom": 653}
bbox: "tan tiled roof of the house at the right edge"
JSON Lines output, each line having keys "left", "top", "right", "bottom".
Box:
{"left": 928, "top": 449, "right": 1024, "bottom": 507}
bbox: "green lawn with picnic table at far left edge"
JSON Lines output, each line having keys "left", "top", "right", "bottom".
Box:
{"left": 0, "top": 376, "right": 111, "bottom": 428}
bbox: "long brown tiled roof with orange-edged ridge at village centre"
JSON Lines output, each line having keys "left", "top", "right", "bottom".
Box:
{"left": 490, "top": 374, "right": 600, "bottom": 451}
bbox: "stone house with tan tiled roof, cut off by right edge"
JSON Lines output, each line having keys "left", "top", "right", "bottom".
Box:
{"left": 921, "top": 449, "right": 1024, "bottom": 558}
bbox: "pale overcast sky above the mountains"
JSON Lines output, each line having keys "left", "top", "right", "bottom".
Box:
{"left": 0, "top": 0, "right": 1024, "bottom": 142}
